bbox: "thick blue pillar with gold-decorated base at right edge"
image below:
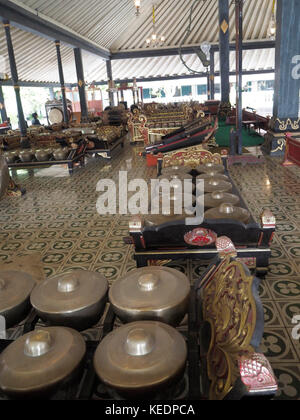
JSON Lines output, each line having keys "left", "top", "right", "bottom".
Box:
{"left": 263, "top": 0, "right": 300, "bottom": 156}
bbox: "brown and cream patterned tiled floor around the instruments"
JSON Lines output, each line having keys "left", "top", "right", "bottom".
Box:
{"left": 0, "top": 145, "right": 300, "bottom": 400}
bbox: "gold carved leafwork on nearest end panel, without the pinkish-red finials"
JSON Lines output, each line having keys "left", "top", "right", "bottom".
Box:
{"left": 201, "top": 255, "right": 256, "bottom": 400}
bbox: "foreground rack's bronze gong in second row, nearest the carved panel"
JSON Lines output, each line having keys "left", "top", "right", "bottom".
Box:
{"left": 109, "top": 267, "right": 190, "bottom": 326}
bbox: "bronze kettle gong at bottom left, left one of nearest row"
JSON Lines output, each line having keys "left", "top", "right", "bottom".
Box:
{"left": 0, "top": 327, "right": 86, "bottom": 398}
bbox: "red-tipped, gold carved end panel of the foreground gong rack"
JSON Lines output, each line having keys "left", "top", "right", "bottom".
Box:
{"left": 200, "top": 237, "right": 278, "bottom": 400}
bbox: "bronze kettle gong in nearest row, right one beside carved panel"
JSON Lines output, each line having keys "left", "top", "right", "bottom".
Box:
{"left": 94, "top": 321, "right": 187, "bottom": 398}
